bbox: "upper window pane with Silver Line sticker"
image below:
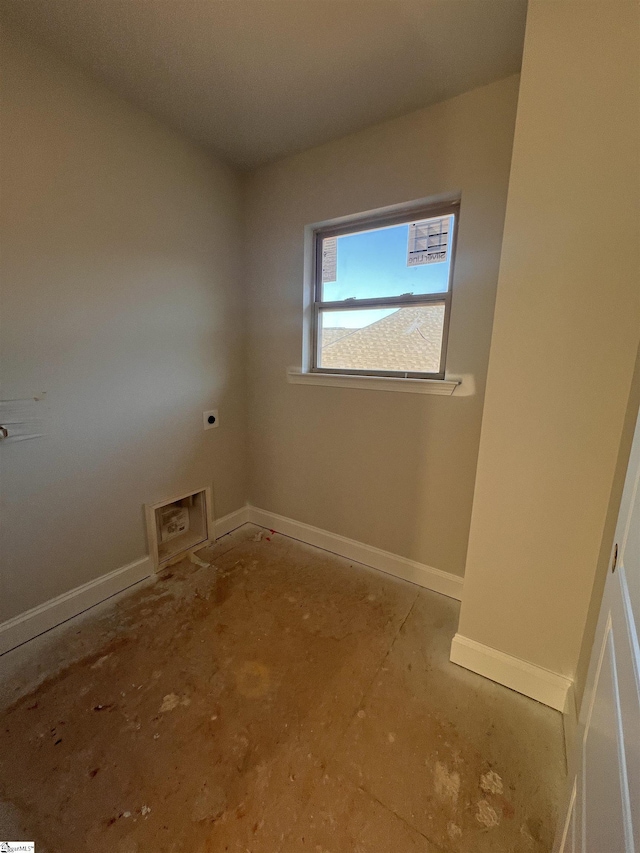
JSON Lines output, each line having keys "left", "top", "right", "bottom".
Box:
{"left": 321, "top": 215, "right": 453, "bottom": 302}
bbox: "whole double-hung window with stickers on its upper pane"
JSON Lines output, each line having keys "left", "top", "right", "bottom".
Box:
{"left": 311, "top": 204, "right": 459, "bottom": 379}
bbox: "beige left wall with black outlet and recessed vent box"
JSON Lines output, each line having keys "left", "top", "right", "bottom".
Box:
{"left": 0, "top": 32, "right": 245, "bottom": 622}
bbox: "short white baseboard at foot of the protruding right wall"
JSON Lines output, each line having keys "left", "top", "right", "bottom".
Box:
{"left": 451, "top": 634, "right": 573, "bottom": 713}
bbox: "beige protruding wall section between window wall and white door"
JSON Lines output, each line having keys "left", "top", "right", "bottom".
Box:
{"left": 459, "top": 0, "right": 640, "bottom": 676}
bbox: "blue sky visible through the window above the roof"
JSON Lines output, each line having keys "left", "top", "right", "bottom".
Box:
{"left": 322, "top": 216, "right": 451, "bottom": 328}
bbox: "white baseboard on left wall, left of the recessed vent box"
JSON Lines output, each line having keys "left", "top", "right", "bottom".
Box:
{"left": 0, "top": 556, "right": 153, "bottom": 655}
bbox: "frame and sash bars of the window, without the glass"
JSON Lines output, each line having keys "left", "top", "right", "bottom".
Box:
{"left": 308, "top": 200, "right": 460, "bottom": 380}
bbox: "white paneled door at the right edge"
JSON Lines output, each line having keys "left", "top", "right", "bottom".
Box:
{"left": 557, "top": 402, "right": 640, "bottom": 853}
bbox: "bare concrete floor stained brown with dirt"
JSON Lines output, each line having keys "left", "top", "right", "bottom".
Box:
{"left": 0, "top": 525, "right": 565, "bottom": 853}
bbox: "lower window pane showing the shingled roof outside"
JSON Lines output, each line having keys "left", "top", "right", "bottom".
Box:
{"left": 318, "top": 302, "right": 444, "bottom": 373}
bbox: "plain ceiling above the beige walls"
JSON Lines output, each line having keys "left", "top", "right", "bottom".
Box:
{"left": 2, "top": 0, "right": 526, "bottom": 167}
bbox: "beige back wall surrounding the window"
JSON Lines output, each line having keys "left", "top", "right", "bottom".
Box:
{"left": 245, "top": 76, "right": 518, "bottom": 575}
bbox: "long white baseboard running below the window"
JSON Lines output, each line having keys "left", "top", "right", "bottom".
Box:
{"left": 247, "top": 506, "right": 463, "bottom": 601}
